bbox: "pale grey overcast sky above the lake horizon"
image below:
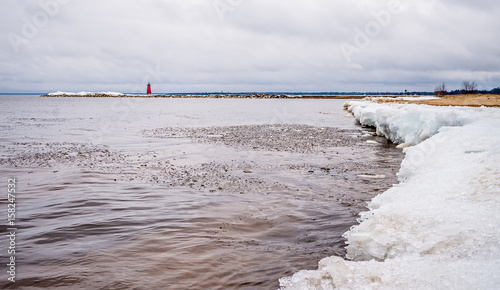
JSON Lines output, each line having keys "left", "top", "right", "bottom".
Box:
{"left": 0, "top": 0, "right": 500, "bottom": 92}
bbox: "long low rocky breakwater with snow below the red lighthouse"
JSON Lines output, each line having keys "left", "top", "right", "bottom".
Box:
{"left": 40, "top": 93, "right": 366, "bottom": 99}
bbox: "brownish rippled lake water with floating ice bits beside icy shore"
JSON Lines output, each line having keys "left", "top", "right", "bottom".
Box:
{"left": 0, "top": 96, "right": 402, "bottom": 289}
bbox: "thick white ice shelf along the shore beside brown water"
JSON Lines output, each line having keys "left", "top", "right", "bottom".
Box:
{"left": 280, "top": 101, "right": 500, "bottom": 289}
